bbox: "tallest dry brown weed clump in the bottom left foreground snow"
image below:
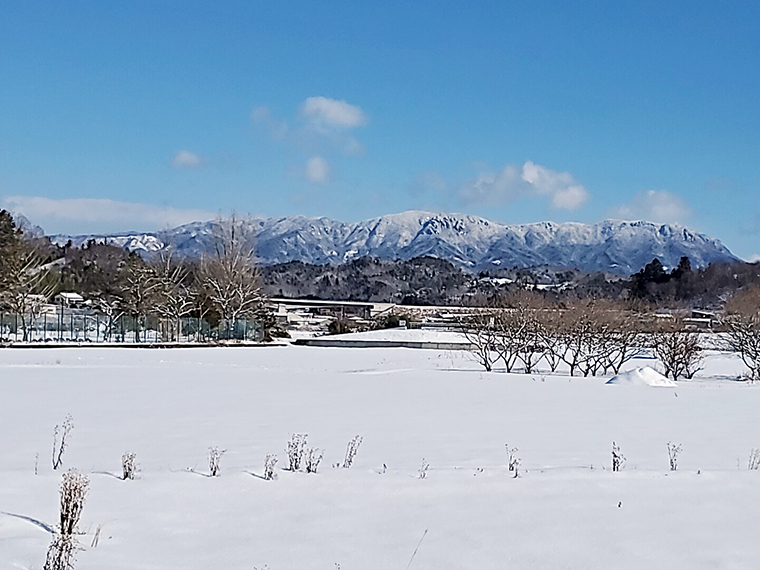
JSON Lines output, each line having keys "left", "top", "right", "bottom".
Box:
{"left": 43, "top": 469, "right": 90, "bottom": 570}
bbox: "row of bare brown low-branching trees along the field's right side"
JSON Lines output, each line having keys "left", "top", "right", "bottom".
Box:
{"left": 461, "top": 286, "right": 760, "bottom": 382}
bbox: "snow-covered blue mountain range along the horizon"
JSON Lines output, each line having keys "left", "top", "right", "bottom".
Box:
{"left": 52, "top": 211, "right": 736, "bottom": 275}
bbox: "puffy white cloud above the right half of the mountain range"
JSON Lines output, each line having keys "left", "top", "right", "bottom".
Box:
{"left": 460, "top": 161, "right": 589, "bottom": 210}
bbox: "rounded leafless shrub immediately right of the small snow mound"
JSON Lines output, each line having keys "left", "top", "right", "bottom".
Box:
{"left": 652, "top": 319, "right": 702, "bottom": 380}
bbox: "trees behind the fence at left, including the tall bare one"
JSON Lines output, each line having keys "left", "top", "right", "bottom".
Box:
{"left": 0, "top": 210, "right": 275, "bottom": 342}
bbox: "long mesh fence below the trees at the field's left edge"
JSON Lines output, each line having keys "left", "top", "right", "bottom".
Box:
{"left": 0, "top": 309, "right": 263, "bottom": 343}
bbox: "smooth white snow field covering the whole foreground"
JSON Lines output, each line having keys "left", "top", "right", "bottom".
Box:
{"left": 0, "top": 346, "right": 760, "bottom": 570}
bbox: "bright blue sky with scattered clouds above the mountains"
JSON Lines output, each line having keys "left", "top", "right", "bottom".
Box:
{"left": 0, "top": 0, "right": 760, "bottom": 258}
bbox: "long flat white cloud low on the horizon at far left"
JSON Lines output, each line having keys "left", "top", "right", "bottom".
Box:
{"left": 0, "top": 196, "right": 215, "bottom": 233}
